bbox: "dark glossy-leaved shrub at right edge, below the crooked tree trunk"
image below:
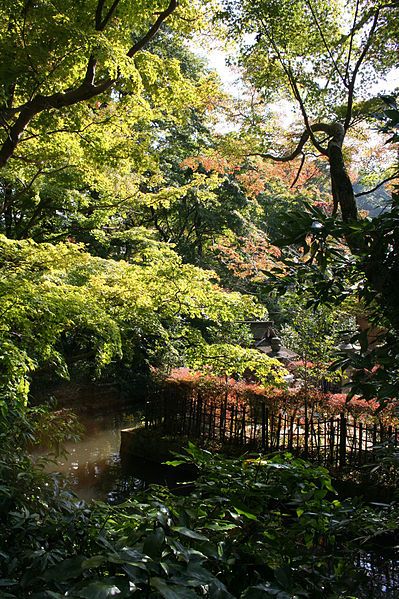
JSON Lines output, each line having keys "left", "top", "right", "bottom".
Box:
{"left": 262, "top": 189, "right": 399, "bottom": 405}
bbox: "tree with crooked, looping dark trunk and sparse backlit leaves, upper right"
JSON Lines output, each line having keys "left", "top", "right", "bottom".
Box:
{"left": 222, "top": 0, "right": 398, "bottom": 234}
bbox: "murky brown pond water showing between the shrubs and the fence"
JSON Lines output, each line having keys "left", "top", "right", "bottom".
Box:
{"left": 44, "top": 405, "right": 399, "bottom": 599}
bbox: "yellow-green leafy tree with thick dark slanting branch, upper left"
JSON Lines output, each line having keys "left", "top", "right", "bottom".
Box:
{"left": 0, "top": 0, "right": 216, "bottom": 240}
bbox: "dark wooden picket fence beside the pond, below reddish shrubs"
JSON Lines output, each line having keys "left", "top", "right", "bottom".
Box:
{"left": 145, "top": 386, "right": 399, "bottom": 469}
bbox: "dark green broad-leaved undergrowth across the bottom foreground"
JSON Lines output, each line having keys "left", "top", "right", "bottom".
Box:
{"left": 0, "top": 444, "right": 397, "bottom": 599}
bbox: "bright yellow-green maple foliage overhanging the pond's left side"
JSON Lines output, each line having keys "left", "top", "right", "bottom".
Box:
{"left": 0, "top": 237, "right": 259, "bottom": 415}
